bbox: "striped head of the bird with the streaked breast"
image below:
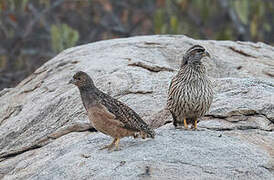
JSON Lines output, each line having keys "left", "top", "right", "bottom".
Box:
{"left": 182, "top": 45, "right": 210, "bottom": 66}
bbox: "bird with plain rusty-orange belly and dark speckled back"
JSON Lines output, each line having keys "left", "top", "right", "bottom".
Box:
{"left": 70, "top": 71, "right": 155, "bottom": 150}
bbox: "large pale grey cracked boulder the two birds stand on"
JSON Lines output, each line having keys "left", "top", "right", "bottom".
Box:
{"left": 0, "top": 36, "right": 274, "bottom": 179}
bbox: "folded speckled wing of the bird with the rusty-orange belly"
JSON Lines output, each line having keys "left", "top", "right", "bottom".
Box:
{"left": 98, "top": 94, "right": 148, "bottom": 131}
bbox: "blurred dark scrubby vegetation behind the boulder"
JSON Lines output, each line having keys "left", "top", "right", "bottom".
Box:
{"left": 0, "top": 0, "right": 274, "bottom": 90}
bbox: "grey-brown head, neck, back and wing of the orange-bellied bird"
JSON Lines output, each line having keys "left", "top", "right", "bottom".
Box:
{"left": 73, "top": 71, "right": 155, "bottom": 138}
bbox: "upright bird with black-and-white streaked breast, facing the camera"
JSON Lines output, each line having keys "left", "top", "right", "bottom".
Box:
{"left": 167, "top": 45, "right": 213, "bottom": 129}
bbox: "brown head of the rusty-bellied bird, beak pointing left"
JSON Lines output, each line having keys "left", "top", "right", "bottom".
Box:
{"left": 69, "top": 71, "right": 94, "bottom": 89}
